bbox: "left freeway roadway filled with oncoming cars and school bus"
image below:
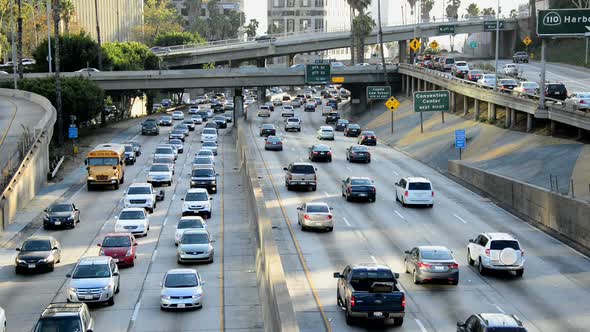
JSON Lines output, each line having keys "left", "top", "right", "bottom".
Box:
{"left": 0, "top": 111, "right": 264, "bottom": 332}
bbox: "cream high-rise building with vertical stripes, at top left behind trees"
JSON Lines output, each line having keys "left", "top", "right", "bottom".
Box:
{"left": 72, "top": 0, "right": 143, "bottom": 42}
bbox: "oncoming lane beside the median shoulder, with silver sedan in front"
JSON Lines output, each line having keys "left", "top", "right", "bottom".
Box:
{"left": 130, "top": 126, "right": 224, "bottom": 331}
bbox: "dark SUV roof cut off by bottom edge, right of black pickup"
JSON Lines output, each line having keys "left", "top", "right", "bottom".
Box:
{"left": 457, "top": 314, "right": 527, "bottom": 332}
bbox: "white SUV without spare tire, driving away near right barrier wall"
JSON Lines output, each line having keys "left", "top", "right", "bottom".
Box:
{"left": 395, "top": 177, "right": 434, "bottom": 208}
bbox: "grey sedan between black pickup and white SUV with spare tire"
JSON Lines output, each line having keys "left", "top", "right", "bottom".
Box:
{"left": 404, "top": 246, "right": 459, "bottom": 285}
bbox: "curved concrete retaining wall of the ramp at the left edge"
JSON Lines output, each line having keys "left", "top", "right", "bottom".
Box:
{"left": 0, "top": 89, "right": 57, "bottom": 230}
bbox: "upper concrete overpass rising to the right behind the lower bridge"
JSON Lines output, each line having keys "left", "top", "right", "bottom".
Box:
{"left": 157, "top": 17, "right": 518, "bottom": 68}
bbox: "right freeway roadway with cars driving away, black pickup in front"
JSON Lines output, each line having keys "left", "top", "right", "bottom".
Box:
{"left": 248, "top": 92, "right": 590, "bottom": 332}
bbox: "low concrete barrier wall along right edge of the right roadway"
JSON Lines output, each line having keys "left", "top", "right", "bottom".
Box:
{"left": 448, "top": 160, "right": 590, "bottom": 254}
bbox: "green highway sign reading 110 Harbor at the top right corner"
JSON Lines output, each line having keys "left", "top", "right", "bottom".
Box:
{"left": 537, "top": 8, "right": 590, "bottom": 36}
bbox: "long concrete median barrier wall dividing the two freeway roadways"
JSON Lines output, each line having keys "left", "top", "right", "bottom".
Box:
{"left": 234, "top": 119, "right": 299, "bottom": 332}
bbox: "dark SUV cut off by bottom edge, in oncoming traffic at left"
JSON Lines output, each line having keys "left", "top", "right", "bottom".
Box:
{"left": 33, "top": 302, "right": 94, "bottom": 332}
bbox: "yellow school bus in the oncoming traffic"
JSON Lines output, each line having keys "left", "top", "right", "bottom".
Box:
{"left": 84, "top": 143, "right": 125, "bottom": 190}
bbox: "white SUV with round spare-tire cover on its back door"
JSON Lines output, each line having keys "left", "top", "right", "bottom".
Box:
{"left": 467, "top": 233, "right": 524, "bottom": 277}
